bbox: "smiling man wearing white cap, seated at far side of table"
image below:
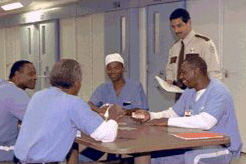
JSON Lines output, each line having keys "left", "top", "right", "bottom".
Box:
{"left": 89, "top": 53, "right": 148, "bottom": 114}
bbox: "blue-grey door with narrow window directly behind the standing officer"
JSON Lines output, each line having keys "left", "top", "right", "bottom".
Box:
{"left": 147, "top": 2, "right": 184, "bottom": 111}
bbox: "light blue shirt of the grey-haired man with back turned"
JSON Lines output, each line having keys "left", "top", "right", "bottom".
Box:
{"left": 14, "top": 87, "right": 103, "bottom": 163}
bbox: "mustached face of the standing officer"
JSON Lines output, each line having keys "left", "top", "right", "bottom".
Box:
{"left": 170, "top": 18, "right": 191, "bottom": 39}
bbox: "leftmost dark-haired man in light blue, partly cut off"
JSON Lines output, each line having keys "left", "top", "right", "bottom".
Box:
{"left": 0, "top": 60, "right": 37, "bottom": 162}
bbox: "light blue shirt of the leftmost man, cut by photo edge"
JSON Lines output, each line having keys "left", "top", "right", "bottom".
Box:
{"left": 0, "top": 79, "right": 30, "bottom": 161}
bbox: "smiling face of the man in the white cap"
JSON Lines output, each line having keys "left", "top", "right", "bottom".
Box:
{"left": 106, "top": 62, "right": 125, "bottom": 82}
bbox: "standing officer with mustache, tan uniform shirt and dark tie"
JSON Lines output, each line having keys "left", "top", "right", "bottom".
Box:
{"left": 166, "top": 8, "right": 222, "bottom": 88}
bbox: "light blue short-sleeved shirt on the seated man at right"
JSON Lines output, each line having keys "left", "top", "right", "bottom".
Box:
{"left": 173, "top": 79, "right": 242, "bottom": 156}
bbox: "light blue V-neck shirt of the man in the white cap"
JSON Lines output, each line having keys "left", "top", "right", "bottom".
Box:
{"left": 90, "top": 79, "right": 148, "bottom": 110}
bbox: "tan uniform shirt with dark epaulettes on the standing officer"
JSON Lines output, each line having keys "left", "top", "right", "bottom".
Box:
{"left": 166, "top": 30, "right": 222, "bottom": 81}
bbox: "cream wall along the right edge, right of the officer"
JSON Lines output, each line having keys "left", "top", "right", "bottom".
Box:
{"left": 223, "top": 0, "right": 246, "bottom": 152}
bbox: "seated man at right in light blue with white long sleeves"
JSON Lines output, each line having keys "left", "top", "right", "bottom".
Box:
{"left": 134, "top": 56, "right": 242, "bottom": 164}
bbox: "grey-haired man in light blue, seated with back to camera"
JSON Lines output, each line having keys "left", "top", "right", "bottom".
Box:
{"left": 14, "top": 59, "right": 122, "bottom": 163}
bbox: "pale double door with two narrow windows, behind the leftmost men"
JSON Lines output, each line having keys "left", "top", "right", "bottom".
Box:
{"left": 20, "top": 21, "right": 59, "bottom": 91}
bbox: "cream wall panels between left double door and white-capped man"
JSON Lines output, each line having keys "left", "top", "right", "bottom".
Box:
{"left": 60, "top": 14, "right": 105, "bottom": 101}
